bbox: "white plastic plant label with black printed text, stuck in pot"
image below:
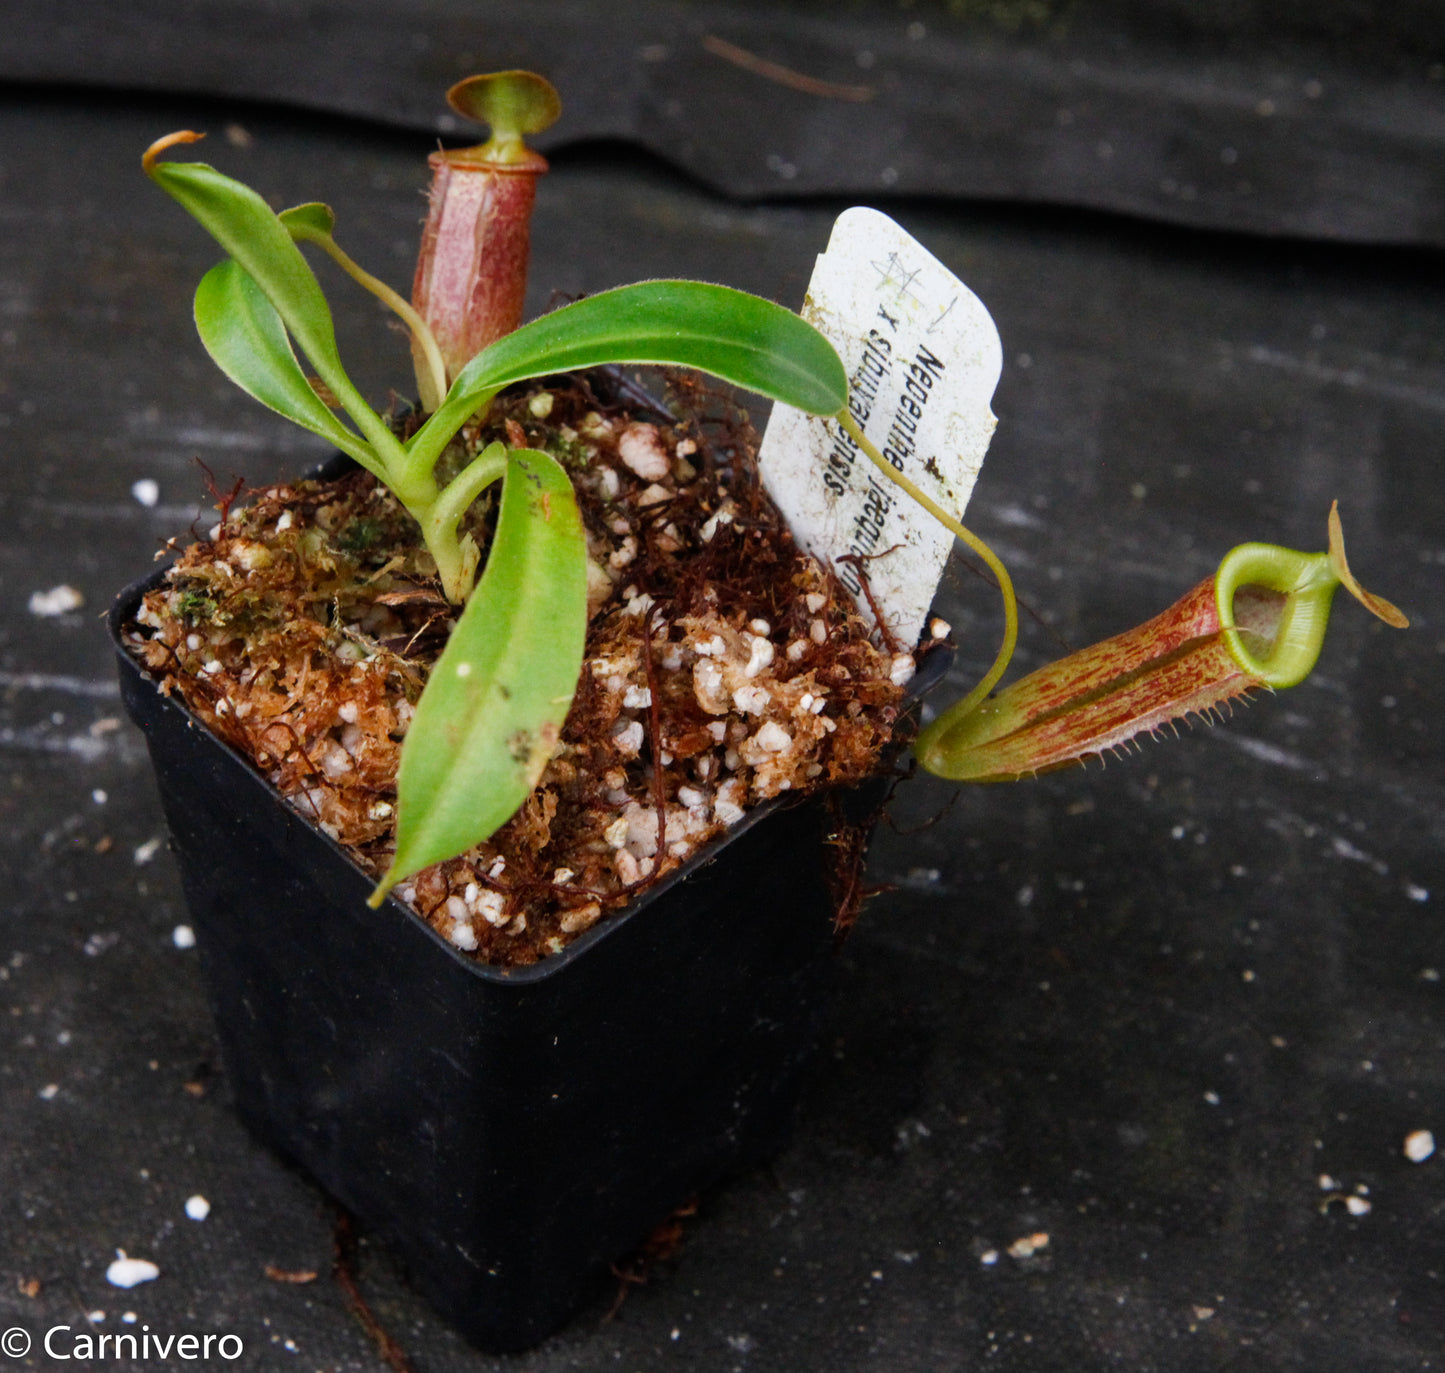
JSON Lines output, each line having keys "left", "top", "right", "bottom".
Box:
{"left": 759, "top": 208, "right": 1003, "bottom": 647}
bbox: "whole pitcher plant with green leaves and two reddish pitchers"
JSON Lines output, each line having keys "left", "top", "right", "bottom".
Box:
{"left": 143, "top": 72, "right": 1406, "bottom": 903}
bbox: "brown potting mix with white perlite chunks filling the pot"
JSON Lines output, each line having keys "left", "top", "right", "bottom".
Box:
{"left": 129, "top": 377, "right": 913, "bottom": 967}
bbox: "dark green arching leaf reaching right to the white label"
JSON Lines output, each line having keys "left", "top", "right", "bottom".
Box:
{"left": 407, "top": 282, "right": 848, "bottom": 471}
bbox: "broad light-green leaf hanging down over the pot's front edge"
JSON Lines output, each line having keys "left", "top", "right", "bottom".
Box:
{"left": 371, "top": 448, "right": 587, "bottom": 905}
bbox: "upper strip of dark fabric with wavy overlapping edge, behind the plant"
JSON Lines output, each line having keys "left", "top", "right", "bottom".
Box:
{"left": 0, "top": 0, "right": 1445, "bottom": 246}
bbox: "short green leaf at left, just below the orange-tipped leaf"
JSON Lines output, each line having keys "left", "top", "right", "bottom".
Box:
{"left": 195, "top": 257, "right": 377, "bottom": 471}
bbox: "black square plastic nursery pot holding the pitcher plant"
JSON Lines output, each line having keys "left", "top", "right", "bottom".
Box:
{"left": 110, "top": 549, "right": 945, "bottom": 1351}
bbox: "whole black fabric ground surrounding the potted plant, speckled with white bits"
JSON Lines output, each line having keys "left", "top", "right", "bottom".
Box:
{"left": 0, "top": 0, "right": 1445, "bottom": 1373}
